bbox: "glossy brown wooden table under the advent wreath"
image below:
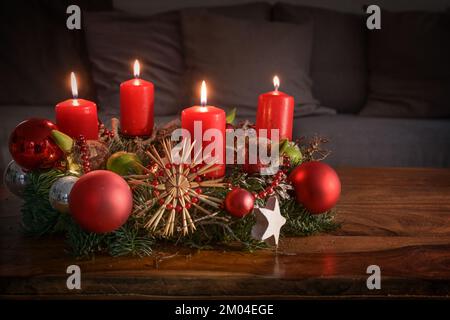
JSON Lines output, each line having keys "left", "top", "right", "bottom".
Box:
{"left": 0, "top": 168, "right": 450, "bottom": 299}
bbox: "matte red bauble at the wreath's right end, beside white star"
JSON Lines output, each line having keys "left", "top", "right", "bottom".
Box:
{"left": 289, "top": 161, "right": 341, "bottom": 214}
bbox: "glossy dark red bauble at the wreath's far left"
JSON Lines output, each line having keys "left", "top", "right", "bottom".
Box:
{"left": 9, "top": 118, "right": 63, "bottom": 170}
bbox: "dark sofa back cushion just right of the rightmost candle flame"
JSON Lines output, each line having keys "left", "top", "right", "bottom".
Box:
{"left": 273, "top": 3, "right": 368, "bottom": 113}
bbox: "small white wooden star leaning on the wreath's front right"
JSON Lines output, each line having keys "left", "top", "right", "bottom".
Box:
{"left": 252, "top": 197, "right": 286, "bottom": 246}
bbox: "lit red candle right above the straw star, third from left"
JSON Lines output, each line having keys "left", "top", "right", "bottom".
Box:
{"left": 181, "top": 81, "right": 226, "bottom": 178}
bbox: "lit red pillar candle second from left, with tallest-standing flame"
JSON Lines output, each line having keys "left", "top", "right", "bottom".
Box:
{"left": 120, "top": 60, "right": 154, "bottom": 136}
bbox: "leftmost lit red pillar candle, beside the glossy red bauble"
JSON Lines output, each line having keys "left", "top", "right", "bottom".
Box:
{"left": 55, "top": 72, "right": 98, "bottom": 140}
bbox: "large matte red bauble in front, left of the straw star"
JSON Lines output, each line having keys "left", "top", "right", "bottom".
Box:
{"left": 69, "top": 170, "right": 133, "bottom": 233}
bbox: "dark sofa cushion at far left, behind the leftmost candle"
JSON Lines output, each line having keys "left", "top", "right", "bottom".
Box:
{"left": 0, "top": 0, "right": 112, "bottom": 105}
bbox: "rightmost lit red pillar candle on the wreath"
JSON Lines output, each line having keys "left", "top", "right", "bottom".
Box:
{"left": 256, "top": 76, "right": 294, "bottom": 141}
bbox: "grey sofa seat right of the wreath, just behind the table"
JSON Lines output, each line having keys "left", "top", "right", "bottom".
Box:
{"left": 293, "top": 115, "right": 450, "bottom": 168}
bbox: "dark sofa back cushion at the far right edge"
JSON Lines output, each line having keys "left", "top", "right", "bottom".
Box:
{"left": 361, "top": 11, "right": 450, "bottom": 117}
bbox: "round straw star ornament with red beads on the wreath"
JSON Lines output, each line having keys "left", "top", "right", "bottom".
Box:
{"left": 128, "top": 139, "right": 227, "bottom": 237}
